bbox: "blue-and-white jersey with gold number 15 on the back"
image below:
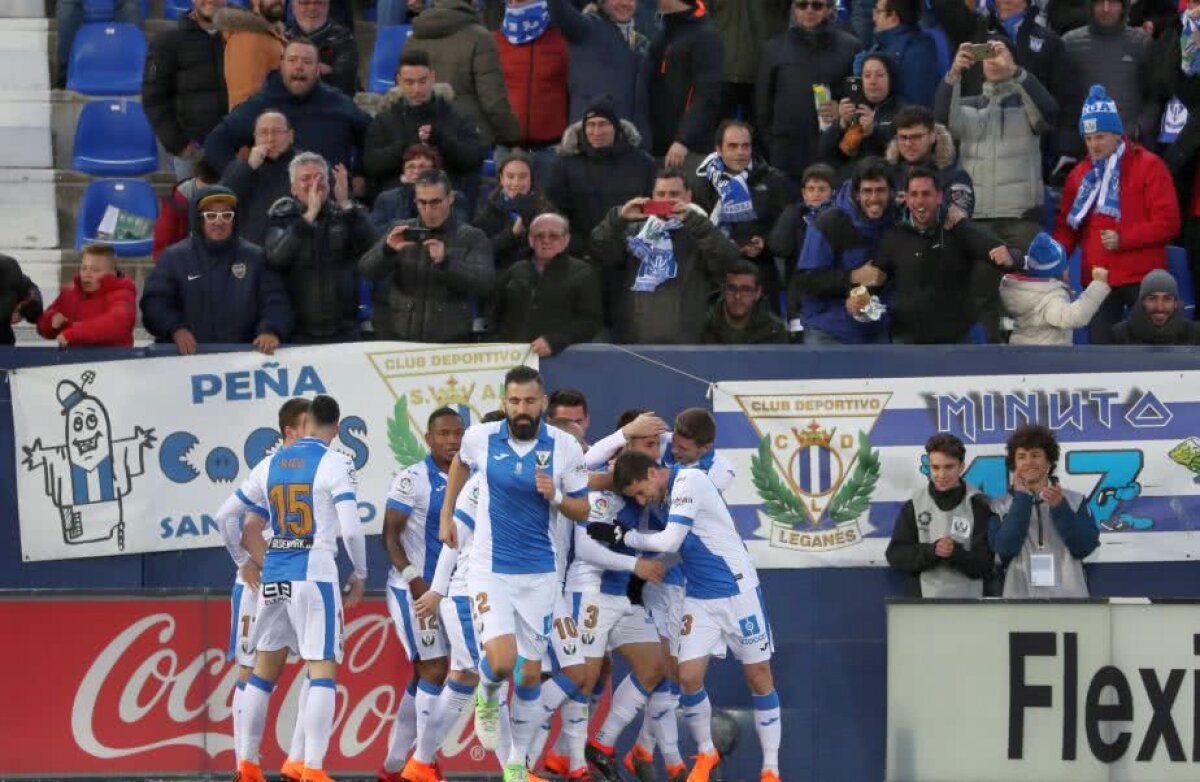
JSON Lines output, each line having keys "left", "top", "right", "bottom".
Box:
{"left": 250, "top": 438, "right": 365, "bottom": 583}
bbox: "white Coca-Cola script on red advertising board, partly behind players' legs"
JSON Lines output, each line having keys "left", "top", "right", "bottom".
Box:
{"left": 71, "top": 604, "right": 484, "bottom": 769}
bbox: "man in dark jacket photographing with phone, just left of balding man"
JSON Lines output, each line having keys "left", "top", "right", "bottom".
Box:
{"left": 359, "top": 170, "right": 496, "bottom": 342}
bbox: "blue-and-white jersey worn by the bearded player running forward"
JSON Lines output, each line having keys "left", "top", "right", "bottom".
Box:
{"left": 458, "top": 421, "right": 588, "bottom": 576}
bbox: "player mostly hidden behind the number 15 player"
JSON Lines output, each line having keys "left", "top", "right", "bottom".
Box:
{"left": 216, "top": 397, "right": 310, "bottom": 782}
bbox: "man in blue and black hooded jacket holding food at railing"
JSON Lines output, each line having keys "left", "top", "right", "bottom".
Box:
{"left": 793, "top": 157, "right": 892, "bottom": 344}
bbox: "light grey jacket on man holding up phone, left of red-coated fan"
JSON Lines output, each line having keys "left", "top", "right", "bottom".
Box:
{"left": 935, "top": 70, "right": 1058, "bottom": 222}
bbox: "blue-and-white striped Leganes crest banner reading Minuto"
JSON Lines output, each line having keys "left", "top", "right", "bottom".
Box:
{"left": 713, "top": 372, "right": 1200, "bottom": 567}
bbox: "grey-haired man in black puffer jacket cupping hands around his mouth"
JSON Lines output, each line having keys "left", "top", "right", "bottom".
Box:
{"left": 264, "top": 152, "right": 376, "bottom": 344}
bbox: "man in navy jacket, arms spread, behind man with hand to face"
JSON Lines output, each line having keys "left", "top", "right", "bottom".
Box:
{"left": 204, "top": 38, "right": 371, "bottom": 178}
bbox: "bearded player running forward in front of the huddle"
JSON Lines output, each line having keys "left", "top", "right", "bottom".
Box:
{"left": 442, "top": 366, "right": 588, "bottom": 782}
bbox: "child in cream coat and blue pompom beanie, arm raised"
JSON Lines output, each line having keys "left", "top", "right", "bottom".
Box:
{"left": 1000, "top": 233, "right": 1109, "bottom": 345}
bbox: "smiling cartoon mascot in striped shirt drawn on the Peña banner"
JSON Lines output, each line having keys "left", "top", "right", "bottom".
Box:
{"left": 22, "top": 371, "right": 155, "bottom": 551}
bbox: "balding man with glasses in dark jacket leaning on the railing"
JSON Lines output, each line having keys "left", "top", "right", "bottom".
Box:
{"left": 491, "top": 212, "right": 601, "bottom": 359}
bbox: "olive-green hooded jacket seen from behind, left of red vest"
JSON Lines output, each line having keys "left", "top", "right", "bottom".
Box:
{"left": 406, "top": 0, "right": 521, "bottom": 146}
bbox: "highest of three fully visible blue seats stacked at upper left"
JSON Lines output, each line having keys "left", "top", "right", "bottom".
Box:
{"left": 67, "top": 22, "right": 146, "bottom": 95}
